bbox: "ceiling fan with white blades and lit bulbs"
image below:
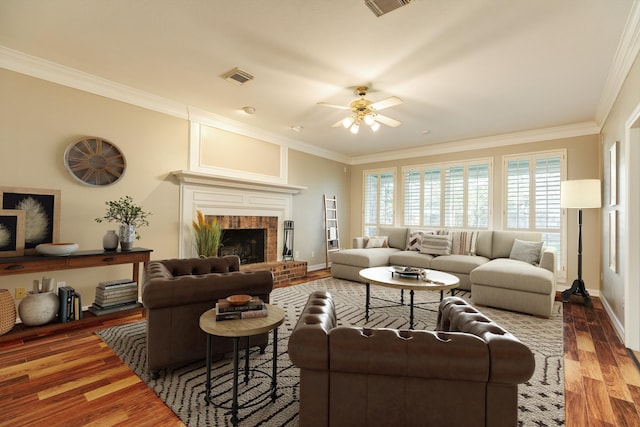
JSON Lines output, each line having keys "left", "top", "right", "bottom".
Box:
{"left": 318, "top": 86, "right": 402, "bottom": 134}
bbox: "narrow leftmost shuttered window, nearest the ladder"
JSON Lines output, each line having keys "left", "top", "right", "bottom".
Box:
{"left": 363, "top": 170, "right": 395, "bottom": 236}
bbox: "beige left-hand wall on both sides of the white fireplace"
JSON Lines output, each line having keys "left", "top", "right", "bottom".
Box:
{"left": 0, "top": 69, "right": 350, "bottom": 314}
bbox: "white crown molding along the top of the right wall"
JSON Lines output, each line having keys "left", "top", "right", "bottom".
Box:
{"left": 596, "top": 0, "right": 640, "bottom": 127}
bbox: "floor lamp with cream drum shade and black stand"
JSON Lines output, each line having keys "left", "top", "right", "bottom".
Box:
{"left": 560, "top": 179, "right": 602, "bottom": 306}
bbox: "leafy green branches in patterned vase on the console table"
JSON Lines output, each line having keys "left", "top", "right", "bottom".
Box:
{"left": 96, "top": 196, "right": 151, "bottom": 251}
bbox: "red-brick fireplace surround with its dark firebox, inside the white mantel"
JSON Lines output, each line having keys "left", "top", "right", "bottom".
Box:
{"left": 205, "top": 215, "right": 278, "bottom": 264}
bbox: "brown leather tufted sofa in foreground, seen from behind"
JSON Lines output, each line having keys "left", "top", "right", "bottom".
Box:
{"left": 289, "top": 291, "right": 535, "bottom": 427}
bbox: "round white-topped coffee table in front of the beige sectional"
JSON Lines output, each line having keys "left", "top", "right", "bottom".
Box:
{"left": 360, "top": 267, "right": 460, "bottom": 329}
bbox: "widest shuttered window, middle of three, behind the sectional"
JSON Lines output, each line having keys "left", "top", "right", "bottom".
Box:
{"left": 403, "top": 160, "right": 491, "bottom": 228}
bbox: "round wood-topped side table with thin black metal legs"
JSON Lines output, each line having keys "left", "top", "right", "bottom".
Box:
{"left": 200, "top": 304, "right": 284, "bottom": 426}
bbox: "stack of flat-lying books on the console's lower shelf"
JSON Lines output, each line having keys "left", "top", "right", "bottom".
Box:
{"left": 88, "top": 279, "right": 141, "bottom": 316}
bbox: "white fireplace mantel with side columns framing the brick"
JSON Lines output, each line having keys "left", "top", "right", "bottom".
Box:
{"left": 171, "top": 171, "right": 306, "bottom": 261}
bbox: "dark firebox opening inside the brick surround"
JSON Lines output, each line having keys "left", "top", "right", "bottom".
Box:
{"left": 218, "top": 228, "right": 267, "bottom": 264}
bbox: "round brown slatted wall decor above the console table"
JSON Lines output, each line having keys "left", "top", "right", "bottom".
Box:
{"left": 64, "top": 137, "right": 127, "bottom": 186}
